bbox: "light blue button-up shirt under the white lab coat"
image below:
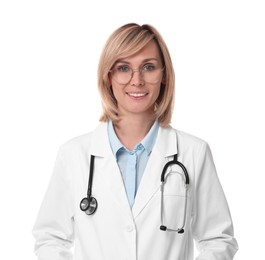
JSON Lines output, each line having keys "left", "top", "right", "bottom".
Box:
{"left": 108, "top": 120, "right": 159, "bottom": 207}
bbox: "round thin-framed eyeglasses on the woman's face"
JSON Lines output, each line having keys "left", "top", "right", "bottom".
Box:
{"left": 109, "top": 64, "right": 164, "bottom": 85}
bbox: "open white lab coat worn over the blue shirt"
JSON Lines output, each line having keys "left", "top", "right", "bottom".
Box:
{"left": 33, "top": 123, "right": 237, "bottom": 260}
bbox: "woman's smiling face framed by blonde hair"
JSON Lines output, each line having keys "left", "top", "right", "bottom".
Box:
{"left": 111, "top": 42, "right": 163, "bottom": 119}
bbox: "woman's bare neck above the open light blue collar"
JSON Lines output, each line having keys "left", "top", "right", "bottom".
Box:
{"left": 114, "top": 114, "right": 155, "bottom": 151}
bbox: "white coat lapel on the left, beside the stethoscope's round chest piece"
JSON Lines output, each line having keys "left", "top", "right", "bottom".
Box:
{"left": 91, "top": 123, "right": 132, "bottom": 218}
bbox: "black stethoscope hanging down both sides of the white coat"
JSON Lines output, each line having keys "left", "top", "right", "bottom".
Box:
{"left": 80, "top": 154, "right": 189, "bottom": 234}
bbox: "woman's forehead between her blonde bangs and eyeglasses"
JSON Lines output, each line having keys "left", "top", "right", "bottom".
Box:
{"left": 116, "top": 41, "right": 161, "bottom": 64}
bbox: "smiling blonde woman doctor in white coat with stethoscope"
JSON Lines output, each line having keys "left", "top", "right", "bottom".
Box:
{"left": 33, "top": 24, "right": 237, "bottom": 260}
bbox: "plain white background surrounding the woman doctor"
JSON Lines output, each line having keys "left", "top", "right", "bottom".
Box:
{"left": 0, "top": 0, "right": 265, "bottom": 260}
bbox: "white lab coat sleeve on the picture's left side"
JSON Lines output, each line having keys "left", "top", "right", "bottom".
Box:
{"left": 33, "top": 146, "right": 74, "bottom": 260}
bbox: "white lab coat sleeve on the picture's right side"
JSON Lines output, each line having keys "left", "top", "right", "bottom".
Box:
{"left": 192, "top": 143, "right": 238, "bottom": 260}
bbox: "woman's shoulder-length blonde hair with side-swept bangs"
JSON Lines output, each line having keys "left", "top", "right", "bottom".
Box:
{"left": 98, "top": 23, "right": 175, "bottom": 126}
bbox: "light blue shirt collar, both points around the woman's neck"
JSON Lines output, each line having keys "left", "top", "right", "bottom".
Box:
{"left": 108, "top": 120, "right": 159, "bottom": 156}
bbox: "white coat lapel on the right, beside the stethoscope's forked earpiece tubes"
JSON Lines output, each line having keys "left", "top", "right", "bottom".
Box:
{"left": 132, "top": 127, "right": 177, "bottom": 218}
